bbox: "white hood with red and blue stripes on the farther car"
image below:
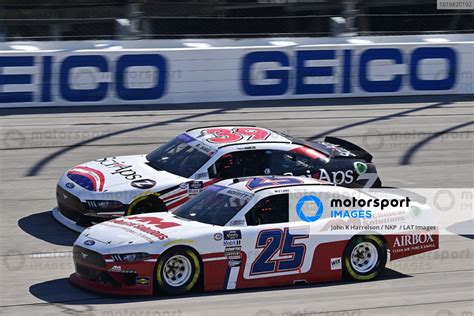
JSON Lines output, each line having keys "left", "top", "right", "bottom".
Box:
{"left": 66, "top": 155, "right": 187, "bottom": 192}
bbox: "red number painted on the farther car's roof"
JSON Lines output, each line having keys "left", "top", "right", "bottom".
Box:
{"left": 203, "top": 127, "right": 270, "bottom": 144}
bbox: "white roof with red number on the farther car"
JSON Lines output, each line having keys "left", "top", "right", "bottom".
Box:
{"left": 186, "top": 125, "right": 292, "bottom": 149}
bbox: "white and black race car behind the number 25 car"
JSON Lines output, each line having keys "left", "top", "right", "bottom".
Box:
{"left": 53, "top": 126, "right": 381, "bottom": 232}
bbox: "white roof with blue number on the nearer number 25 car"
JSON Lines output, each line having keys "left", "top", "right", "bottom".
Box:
{"left": 216, "top": 176, "right": 332, "bottom": 193}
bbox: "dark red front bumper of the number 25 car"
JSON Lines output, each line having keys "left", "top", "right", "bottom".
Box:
{"left": 69, "top": 246, "right": 158, "bottom": 296}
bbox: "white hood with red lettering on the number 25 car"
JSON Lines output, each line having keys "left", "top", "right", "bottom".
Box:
{"left": 75, "top": 213, "right": 212, "bottom": 254}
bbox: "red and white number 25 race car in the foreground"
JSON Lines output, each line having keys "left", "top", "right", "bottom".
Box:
{"left": 70, "top": 176, "right": 439, "bottom": 295}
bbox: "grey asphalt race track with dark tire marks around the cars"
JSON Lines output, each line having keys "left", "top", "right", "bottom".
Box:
{"left": 0, "top": 95, "right": 474, "bottom": 316}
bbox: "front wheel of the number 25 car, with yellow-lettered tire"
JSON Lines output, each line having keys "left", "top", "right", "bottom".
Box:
{"left": 154, "top": 247, "right": 202, "bottom": 295}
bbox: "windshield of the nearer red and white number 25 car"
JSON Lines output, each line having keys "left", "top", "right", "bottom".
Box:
{"left": 172, "top": 185, "right": 253, "bottom": 226}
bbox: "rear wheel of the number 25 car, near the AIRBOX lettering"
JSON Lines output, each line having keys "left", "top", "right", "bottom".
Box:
{"left": 342, "top": 235, "right": 387, "bottom": 281}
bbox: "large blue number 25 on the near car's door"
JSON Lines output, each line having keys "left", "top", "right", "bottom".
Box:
{"left": 250, "top": 228, "right": 308, "bottom": 275}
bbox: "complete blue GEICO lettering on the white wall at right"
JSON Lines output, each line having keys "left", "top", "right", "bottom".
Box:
{"left": 241, "top": 47, "right": 458, "bottom": 96}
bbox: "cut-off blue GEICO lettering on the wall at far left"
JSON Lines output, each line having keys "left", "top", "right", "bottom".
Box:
{"left": 0, "top": 54, "right": 168, "bottom": 103}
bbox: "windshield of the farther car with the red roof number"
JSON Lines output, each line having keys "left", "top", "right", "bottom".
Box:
{"left": 146, "top": 134, "right": 214, "bottom": 178}
